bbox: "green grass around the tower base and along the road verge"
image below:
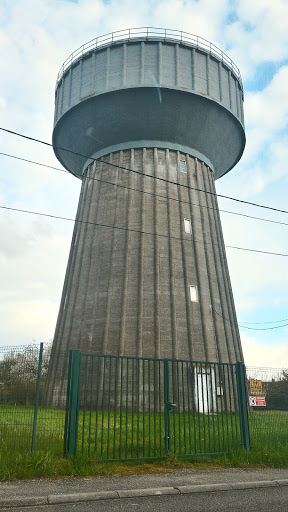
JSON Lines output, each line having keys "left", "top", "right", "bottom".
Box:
{"left": 0, "top": 406, "right": 288, "bottom": 480}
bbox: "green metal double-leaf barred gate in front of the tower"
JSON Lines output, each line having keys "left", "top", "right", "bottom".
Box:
{"left": 64, "top": 350, "right": 249, "bottom": 461}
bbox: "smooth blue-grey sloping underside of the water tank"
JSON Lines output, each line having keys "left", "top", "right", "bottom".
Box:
{"left": 53, "top": 87, "right": 245, "bottom": 179}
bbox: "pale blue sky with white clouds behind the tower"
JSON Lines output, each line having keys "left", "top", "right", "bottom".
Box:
{"left": 0, "top": 0, "right": 288, "bottom": 368}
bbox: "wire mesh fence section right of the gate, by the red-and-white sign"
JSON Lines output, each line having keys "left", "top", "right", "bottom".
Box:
{"left": 246, "top": 366, "right": 288, "bottom": 449}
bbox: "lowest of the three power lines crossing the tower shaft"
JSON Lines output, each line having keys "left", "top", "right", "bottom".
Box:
{"left": 0, "top": 205, "right": 288, "bottom": 257}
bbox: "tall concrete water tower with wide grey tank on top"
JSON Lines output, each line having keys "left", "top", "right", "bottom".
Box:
{"left": 49, "top": 28, "right": 245, "bottom": 402}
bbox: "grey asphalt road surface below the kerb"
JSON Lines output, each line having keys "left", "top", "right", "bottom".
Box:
{"left": 1, "top": 486, "right": 288, "bottom": 512}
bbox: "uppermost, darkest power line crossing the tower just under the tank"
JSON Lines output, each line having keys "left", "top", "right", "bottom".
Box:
{"left": 0, "top": 127, "right": 288, "bottom": 218}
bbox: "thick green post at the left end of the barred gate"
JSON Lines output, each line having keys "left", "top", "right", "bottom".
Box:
{"left": 64, "top": 350, "right": 81, "bottom": 455}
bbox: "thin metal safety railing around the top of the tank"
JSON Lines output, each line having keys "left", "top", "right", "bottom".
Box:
{"left": 56, "top": 27, "right": 242, "bottom": 87}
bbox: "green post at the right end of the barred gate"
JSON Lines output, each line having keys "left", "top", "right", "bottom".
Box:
{"left": 236, "top": 361, "right": 250, "bottom": 450}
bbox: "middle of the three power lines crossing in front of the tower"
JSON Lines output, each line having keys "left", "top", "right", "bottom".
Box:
{"left": 0, "top": 152, "right": 288, "bottom": 230}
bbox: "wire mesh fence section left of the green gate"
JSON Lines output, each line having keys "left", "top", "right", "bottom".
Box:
{"left": 0, "top": 344, "right": 65, "bottom": 454}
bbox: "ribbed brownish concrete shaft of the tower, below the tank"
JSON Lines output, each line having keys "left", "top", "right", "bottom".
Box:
{"left": 49, "top": 149, "right": 243, "bottom": 404}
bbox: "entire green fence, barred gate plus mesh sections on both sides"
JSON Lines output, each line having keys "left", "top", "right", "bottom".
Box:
{"left": 0, "top": 345, "right": 288, "bottom": 460}
